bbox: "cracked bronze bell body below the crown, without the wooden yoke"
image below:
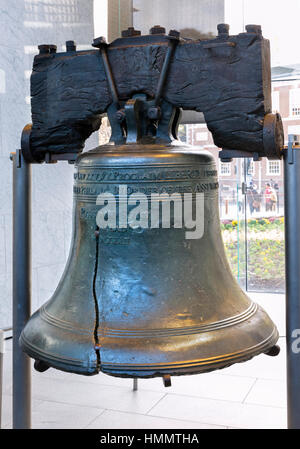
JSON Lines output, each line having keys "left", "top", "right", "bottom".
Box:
{"left": 21, "top": 139, "right": 278, "bottom": 378}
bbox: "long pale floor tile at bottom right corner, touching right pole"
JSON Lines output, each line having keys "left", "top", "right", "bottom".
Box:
{"left": 149, "top": 395, "right": 286, "bottom": 429}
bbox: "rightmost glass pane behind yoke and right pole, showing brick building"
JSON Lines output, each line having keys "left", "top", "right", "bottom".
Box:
{"left": 224, "top": 0, "right": 292, "bottom": 293}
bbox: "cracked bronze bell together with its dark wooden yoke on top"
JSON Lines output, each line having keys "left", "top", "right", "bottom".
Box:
{"left": 20, "top": 25, "right": 283, "bottom": 384}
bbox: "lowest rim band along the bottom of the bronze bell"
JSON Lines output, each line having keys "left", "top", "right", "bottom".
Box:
{"left": 19, "top": 325, "right": 279, "bottom": 378}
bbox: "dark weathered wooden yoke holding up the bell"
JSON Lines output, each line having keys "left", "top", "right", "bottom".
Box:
{"left": 30, "top": 24, "right": 283, "bottom": 161}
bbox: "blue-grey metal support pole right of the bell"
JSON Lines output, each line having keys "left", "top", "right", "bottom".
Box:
{"left": 284, "top": 136, "right": 300, "bottom": 429}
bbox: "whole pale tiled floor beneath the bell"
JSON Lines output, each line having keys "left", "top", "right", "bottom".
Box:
{"left": 3, "top": 294, "right": 286, "bottom": 429}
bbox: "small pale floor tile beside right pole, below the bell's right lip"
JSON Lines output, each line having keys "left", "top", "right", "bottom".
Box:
{"left": 245, "top": 379, "right": 287, "bottom": 408}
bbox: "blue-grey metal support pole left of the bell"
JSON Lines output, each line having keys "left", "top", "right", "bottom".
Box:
{"left": 12, "top": 150, "right": 31, "bottom": 429}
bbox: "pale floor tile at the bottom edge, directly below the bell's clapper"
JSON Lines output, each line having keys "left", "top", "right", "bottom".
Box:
{"left": 87, "top": 410, "right": 226, "bottom": 429}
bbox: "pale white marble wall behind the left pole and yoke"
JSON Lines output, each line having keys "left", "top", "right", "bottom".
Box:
{"left": 0, "top": 0, "right": 98, "bottom": 327}
